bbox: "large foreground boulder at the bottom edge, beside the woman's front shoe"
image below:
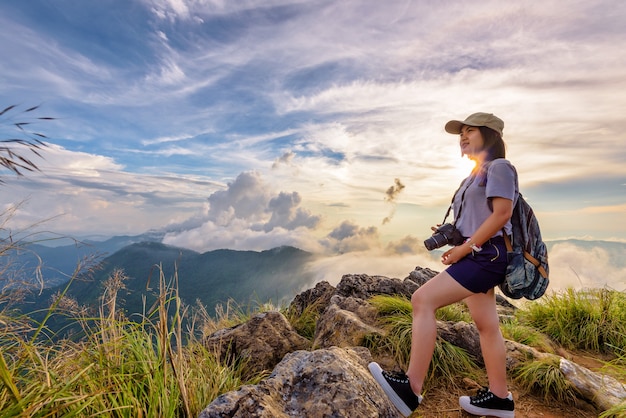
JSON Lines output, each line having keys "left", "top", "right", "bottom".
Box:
{"left": 199, "top": 347, "right": 399, "bottom": 418}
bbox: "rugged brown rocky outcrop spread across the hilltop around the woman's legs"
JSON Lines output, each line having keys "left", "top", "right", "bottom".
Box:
{"left": 200, "top": 267, "right": 626, "bottom": 418}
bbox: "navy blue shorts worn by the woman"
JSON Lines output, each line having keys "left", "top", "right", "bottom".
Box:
{"left": 446, "top": 237, "right": 508, "bottom": 293}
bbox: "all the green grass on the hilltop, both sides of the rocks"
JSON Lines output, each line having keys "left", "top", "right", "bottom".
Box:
{"left": 6, "top": 280, "right": 626, "bottom": 418}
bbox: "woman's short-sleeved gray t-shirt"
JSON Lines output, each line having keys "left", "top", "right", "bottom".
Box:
{"left": 453, "top": 158, "right": 519, "bottom": 237}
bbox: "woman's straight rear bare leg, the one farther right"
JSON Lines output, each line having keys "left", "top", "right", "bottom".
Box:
{"left": 465, "top": 289, "right": 509, "bottom": 398}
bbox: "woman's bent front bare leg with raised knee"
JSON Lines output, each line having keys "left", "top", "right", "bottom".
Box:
{"left": 406, "top": 271, "right": 473, "bottom": 395}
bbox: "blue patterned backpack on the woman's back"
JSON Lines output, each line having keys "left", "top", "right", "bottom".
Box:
{"left": 499, "top": 194, "right": 550, "bottom": 300}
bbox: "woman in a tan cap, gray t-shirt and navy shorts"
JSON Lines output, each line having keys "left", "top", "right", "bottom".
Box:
{"left": 369, "top": 113, "right": 519, "bottom": 418}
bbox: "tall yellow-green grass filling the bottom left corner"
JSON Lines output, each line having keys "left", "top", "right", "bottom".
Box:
{"left": 0, "top": 271, "right": 260, "bottom": 417}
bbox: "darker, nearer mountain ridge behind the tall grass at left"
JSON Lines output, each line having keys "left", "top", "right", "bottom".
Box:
{"left": 19, "top": 242, "right": 315, "bottom": 332}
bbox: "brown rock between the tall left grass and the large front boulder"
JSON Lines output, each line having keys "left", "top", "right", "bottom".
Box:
{"left": 204, "top": 311, "right": 311, "bottom": 375}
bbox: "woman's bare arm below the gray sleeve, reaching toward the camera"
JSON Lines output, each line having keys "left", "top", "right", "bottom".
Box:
{"left": 441, "top": 197, "right": 513, "bottom": 264}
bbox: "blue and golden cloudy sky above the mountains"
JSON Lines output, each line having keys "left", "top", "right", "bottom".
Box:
{"left": 0, "top": 0, "right": 626, "bottom": 292}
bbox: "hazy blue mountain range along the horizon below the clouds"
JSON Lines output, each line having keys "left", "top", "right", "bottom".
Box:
{"left": 2, "top": 232, "right": 626, "bottom": 330}
